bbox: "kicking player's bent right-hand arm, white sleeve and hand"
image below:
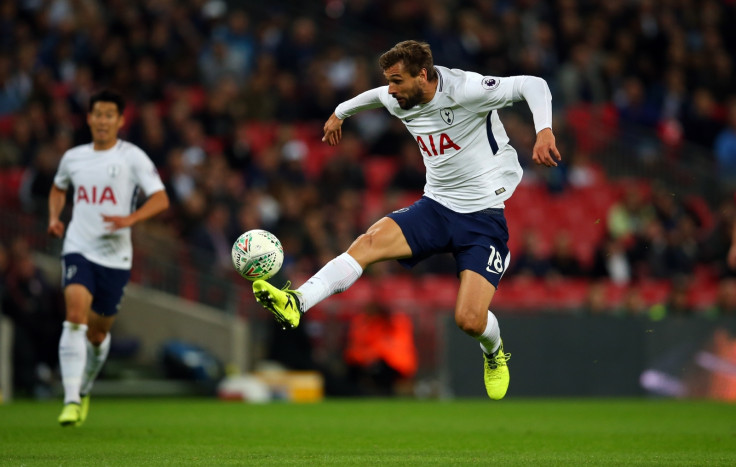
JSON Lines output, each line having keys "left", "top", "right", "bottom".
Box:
{"left": 514, "top": 76, "right": 562, "bottom": 167}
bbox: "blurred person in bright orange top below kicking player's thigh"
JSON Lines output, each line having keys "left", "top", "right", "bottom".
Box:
{"left": 345, "top": 302, "right": 417, "bottom": 396}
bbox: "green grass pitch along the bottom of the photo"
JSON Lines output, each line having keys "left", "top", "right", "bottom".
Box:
{"left": 0, "top": 397, "right": 736, "bottom": 466}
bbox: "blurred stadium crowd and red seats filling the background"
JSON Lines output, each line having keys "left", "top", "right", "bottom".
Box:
{"left": 0, "top": 0, "right": 736, "bottom": 326}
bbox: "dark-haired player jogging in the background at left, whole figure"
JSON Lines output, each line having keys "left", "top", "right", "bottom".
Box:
{"left": 48, "top": 91, "right": 169, "bottom": 426}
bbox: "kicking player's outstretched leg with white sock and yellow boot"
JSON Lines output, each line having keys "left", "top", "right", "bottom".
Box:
{"left": 253, "top": 217, "right": 411, "bottom": 327}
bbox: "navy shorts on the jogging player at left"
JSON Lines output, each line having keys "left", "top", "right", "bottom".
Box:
{"left": 61, "top": 253, "right": 130, "bottom": 316}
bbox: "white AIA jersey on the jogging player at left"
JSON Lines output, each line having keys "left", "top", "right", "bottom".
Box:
{"left": 54, "top": 140, "right": 164, "bottom": 269}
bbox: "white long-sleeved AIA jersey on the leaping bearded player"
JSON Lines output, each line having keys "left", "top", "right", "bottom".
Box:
{"left": 335, "top": 66, "right": 552, "bottom": 213}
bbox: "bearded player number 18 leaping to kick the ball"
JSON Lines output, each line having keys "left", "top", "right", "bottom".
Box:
{"left": 253, "top": 41, "right": 561, "bottom": 400}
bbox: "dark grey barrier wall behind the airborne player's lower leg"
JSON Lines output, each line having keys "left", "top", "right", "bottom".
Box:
{"left": 442, "top": 315, "right": 736, "bottom": 398}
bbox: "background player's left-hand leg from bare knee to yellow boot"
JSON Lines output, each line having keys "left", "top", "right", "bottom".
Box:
{"left": 59, "top": 284, "right": 92, "bottom": 426}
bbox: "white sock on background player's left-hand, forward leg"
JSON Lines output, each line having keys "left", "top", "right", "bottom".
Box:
{"left": 59, "top": 321, "right": 87, "bottom": 404}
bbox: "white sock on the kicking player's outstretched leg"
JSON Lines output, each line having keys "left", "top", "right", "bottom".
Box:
{"left": 297, "top": 253, "right": 363, "bottom": 312}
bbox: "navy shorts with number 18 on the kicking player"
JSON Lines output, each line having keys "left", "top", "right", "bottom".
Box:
{"left": 388, "top": 196, "right": 510, "bottom": 288}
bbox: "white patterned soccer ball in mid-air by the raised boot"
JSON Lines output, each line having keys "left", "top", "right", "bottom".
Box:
{"left": 232, "top": 229, "right": 284, "bottom": 281}
